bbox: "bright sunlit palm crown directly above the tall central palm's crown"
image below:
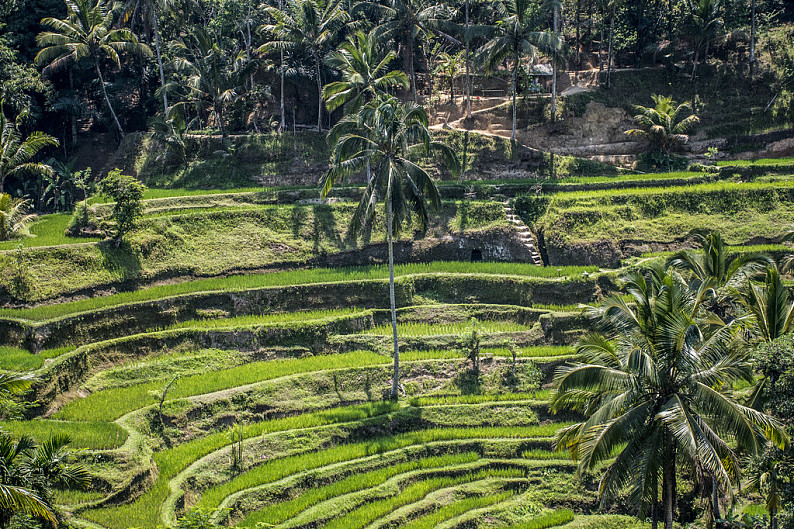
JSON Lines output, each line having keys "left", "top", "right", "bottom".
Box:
{"left": 323, "top": 30, "right": 409, "bottom": 113}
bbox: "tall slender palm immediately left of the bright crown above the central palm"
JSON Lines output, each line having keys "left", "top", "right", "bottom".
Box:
{"left": 258, "top": 0, "right": 349, "bottom": 132}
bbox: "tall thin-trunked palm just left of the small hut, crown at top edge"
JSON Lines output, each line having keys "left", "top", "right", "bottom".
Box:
{"left": 479, "top": 0, "right": 563, "bottom": 141}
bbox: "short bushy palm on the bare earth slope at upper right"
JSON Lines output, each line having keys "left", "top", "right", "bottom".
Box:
{"left": 626, "top": 95, "right": 700, "bottom": 154}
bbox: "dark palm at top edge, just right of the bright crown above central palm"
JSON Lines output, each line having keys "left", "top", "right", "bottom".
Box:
{"left": 360, "top": 0, "right": 451, "bottom": 101}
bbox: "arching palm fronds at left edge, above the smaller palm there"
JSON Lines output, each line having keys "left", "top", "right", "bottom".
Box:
{"left": 0, "top": 102, "right": 58, "bottom": 194}
